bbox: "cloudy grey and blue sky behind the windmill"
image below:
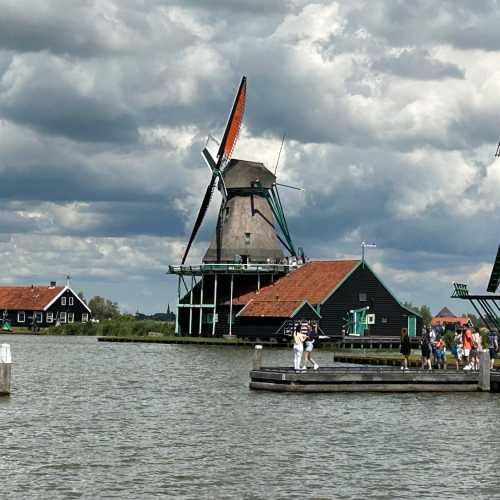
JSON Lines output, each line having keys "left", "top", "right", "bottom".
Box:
{"left": 0, "top": 0, "right": 500, "bottom": 312}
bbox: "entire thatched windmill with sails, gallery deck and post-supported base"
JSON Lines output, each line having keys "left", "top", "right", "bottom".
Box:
{"left": 169, "top": 77, "right": 303, "bottom": 335}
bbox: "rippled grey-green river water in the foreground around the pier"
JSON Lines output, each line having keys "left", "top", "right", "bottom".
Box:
{"left": 0, "top": 335, "right": 500, "bottom": 500}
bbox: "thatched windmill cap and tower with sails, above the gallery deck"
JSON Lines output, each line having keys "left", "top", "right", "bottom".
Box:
{"left": 182, "top": 76, "right": 297, "bottom": 265}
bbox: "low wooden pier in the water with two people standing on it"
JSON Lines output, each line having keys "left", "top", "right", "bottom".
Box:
{"left": 250, "top": 347, "right": 500, "bottom": 392}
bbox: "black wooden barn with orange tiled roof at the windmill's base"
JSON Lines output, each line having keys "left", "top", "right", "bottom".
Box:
{"left": 172, "top": 260, "right": 422, "bottom": 339}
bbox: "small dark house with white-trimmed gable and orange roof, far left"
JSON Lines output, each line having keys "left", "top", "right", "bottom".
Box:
{"left": 0, "top": 281, "right": 92, "bottom": 328}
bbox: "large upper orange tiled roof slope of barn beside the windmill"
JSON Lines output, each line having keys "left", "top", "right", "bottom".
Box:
{"left": 233, "top": 260, "right": 360, "bottom": 305}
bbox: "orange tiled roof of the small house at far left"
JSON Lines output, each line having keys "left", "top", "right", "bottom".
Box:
{"left": 0, "top": 285, "right": 64, "bottom": 311}
